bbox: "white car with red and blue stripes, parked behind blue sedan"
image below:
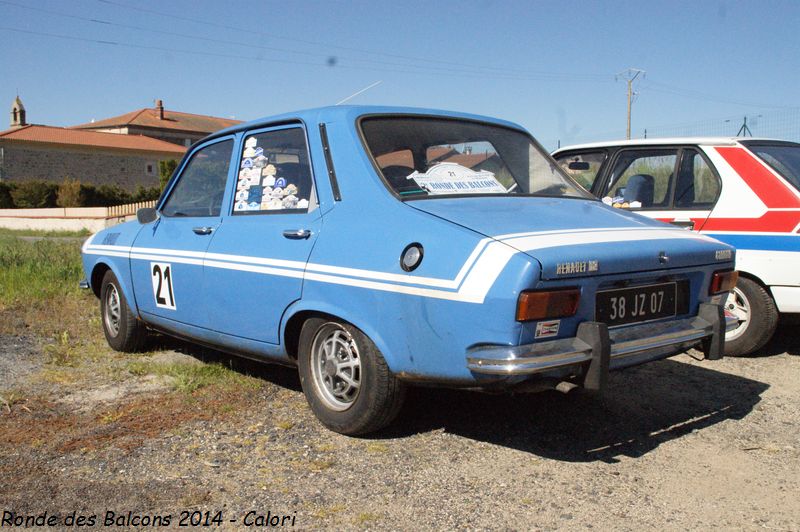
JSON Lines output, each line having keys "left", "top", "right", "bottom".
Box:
{"left": 553, "top": 137, "right": 800, "bottom": 355}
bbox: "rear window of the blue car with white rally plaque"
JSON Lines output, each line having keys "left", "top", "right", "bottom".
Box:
{"left": 361, "top": 116, "right": 592, "bottom": 199}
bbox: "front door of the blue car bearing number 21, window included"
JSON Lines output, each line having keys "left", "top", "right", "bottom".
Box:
{"left": 131, "top": 137, "right": 233, "bottom": 327}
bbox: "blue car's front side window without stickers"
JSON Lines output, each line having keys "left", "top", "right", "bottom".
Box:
{"left": 161, "top": 139, "right": 233, "bottom": 216}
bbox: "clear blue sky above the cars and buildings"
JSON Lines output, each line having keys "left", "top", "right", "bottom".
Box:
{"left": 0, "top": 0, "right": 800, "bottom": 148}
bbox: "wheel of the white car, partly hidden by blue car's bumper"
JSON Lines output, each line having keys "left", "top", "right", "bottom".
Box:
{"left": 725, "top": 277, "right": 778, "bottom": 357}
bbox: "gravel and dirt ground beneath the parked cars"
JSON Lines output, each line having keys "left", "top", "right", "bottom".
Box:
{"left": 0, "top": 316, "right": 800, "bottom": 530}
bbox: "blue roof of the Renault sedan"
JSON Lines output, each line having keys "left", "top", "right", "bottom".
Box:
{"left": 206, "top": 105, "right": 525, "bottom": 139}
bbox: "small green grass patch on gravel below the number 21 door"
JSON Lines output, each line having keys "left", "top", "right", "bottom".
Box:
{"left": 127, "top": 360, "right": 258, "bottom": 394}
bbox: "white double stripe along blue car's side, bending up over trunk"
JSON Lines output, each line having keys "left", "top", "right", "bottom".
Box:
{"left": 83, "top": 228, "right": 713, "bottom": 303}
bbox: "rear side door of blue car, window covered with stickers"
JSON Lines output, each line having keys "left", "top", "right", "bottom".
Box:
{"left": 203, "top": 124, "right": 321, "bottom": 344}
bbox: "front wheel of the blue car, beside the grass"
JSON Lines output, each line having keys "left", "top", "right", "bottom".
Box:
{"left": 100, "top": 270, "right": 147, "bottom": 353}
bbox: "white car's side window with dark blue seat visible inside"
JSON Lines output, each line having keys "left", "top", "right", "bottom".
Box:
{"left": 606, "top": 148, "right": 678, "bottom": 209}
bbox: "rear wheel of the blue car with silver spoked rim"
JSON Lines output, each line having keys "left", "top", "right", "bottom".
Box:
{"left": 298, "top": 318, "right": 406, "bottom": 436}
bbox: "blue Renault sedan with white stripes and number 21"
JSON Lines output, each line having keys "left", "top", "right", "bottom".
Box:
{"left": 83, "top": 107, "right": 736, "bottom": 434}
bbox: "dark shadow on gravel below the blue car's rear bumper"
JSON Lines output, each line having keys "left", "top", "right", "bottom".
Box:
{"left": 381, "top": 360, "right": 769, "bottom": 462}
